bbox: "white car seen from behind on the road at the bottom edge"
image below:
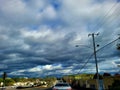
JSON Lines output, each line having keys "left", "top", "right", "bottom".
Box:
{"left": 52, "top": 83, "right": 72, "bottom": 90}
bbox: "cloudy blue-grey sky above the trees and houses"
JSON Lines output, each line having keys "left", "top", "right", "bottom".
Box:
{"left": 0, "top": 0, "right": 120, "bottom": 77}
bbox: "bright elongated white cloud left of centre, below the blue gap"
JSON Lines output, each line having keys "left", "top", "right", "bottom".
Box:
{"left": 21, "top": 26, "right": 65, "bottom": 43}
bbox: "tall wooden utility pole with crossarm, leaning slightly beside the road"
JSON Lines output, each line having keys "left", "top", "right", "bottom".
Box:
{"left": 88, "top": 33, "right": 100, "bottom": 90}
